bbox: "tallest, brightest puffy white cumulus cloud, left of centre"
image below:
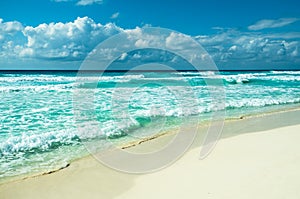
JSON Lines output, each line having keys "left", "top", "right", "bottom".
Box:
{"left": 23, "top": 17, "right": 122, "bottom": 60}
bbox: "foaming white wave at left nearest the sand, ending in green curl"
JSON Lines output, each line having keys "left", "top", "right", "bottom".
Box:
{"left": 0, "top": 118, "right": 151, "bottom": 156}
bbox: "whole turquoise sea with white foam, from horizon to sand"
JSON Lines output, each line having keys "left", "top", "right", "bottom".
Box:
{"left": 0, "top": 71, "right": 300, "bottom": 179}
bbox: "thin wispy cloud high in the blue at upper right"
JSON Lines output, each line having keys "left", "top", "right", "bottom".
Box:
{"left": 248, "top": 18, "right": 299, "bottom": 30}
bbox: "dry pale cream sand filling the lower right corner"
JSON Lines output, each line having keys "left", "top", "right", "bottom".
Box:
{"left": 117, "top": 125, "right": 300, "bottom": 199}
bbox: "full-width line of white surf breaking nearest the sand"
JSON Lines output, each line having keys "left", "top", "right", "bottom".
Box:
{"left": 0, "top": 94, "right": 300, "bottom": 158}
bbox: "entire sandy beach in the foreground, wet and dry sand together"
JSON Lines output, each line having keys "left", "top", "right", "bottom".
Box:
{"left": 0, "top": 110, "right": 300, "bottom": 199}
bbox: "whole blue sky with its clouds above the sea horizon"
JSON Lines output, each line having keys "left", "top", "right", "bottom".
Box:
{"left": 0, "top": 0, "right": 300, "bottom": 70}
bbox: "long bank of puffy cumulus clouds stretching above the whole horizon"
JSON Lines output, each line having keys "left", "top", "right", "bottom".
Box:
{"left": 0, "top": 17, "right": 300, "bottom": 67}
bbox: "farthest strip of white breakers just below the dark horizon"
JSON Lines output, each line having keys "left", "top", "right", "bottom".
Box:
{"left": 0, "top": 71, "right": 300, "bottom": 88}
